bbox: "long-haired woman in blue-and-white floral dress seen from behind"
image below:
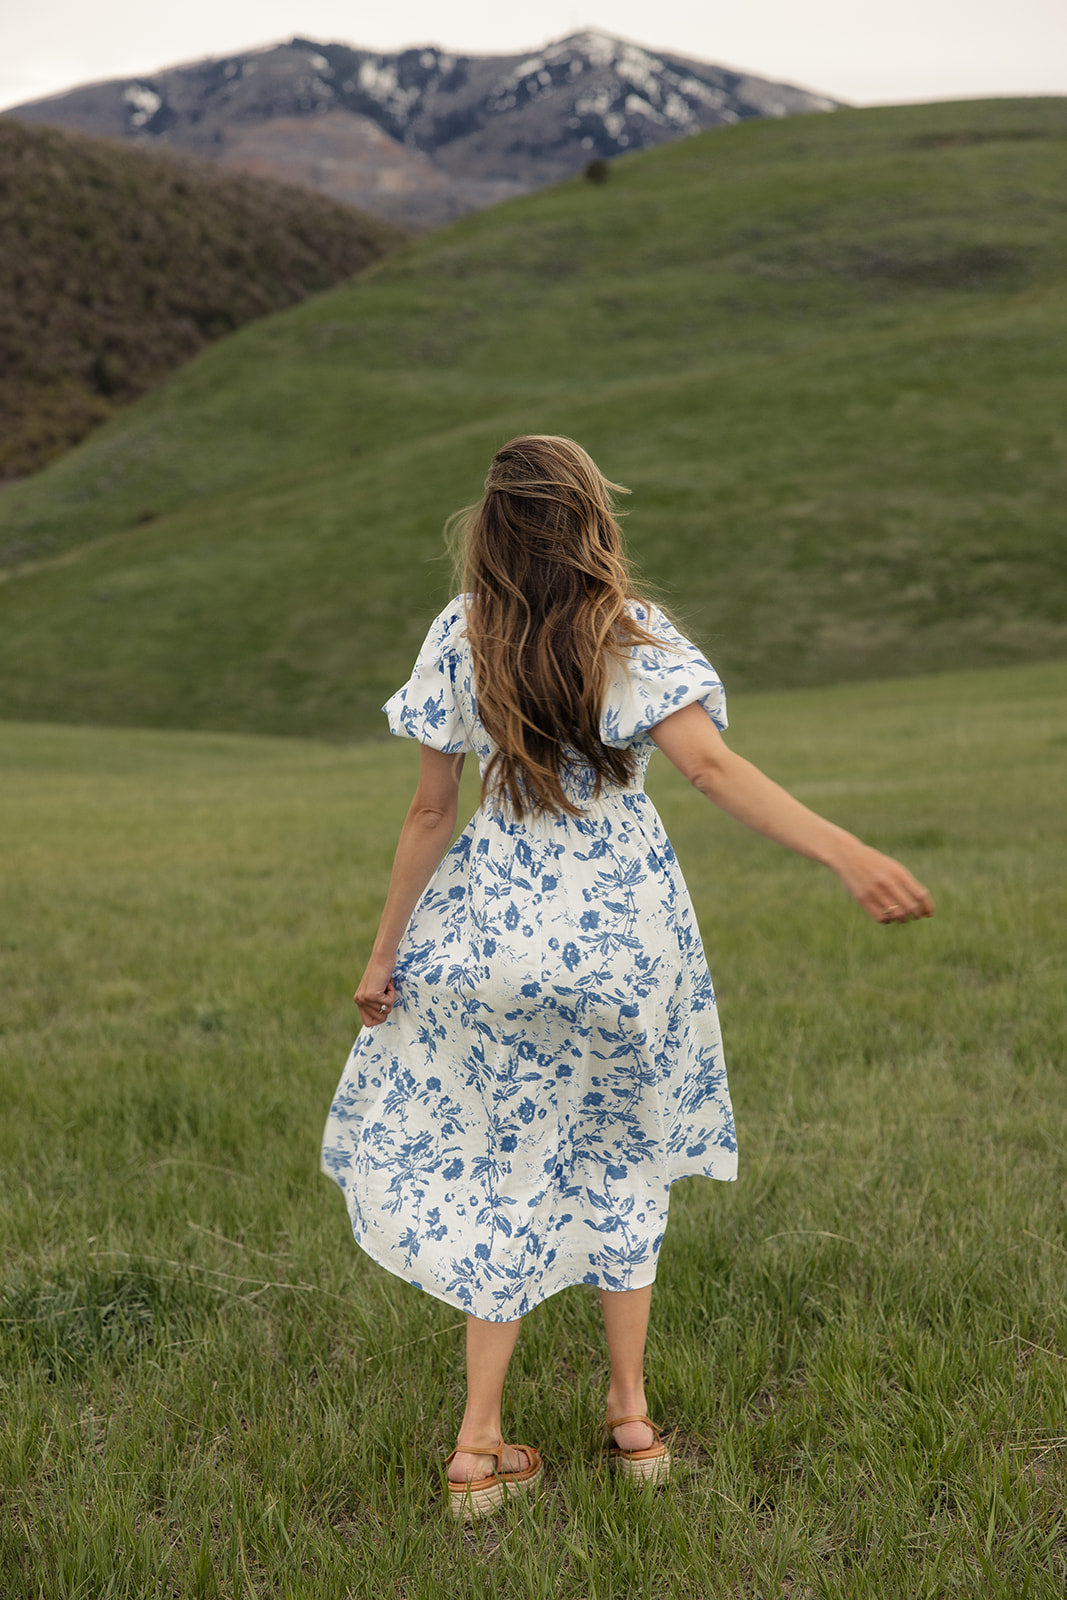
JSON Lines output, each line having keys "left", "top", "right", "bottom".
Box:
{"left": 323, "top": 437, "right": 933, "bottom": 1517}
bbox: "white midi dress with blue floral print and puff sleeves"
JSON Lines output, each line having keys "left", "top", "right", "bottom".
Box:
{"left": 322, "top": 595, "right": 737, "bottom": 1322}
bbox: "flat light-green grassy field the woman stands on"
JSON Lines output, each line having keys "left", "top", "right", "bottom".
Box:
{"left": 0, "top": 666, "right": 1067, "bottom": 1600}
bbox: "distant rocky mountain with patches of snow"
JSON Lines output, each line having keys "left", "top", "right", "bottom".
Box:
{"left": 5, "top": 32, "right": 835, "bottom": 227}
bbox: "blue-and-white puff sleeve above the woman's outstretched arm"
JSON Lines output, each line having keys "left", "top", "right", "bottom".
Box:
{"left": 600, "top": 606, "right": 726, "bottom": 749}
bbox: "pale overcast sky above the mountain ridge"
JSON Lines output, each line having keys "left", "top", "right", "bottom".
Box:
{"left": 0, "top": 0, "right": 1067, "bottom": 107}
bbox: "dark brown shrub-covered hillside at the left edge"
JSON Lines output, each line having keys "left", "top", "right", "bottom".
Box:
{"left": 0, "top": 117, "right": 406, "bottom": 477}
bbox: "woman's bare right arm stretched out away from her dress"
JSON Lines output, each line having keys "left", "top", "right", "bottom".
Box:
{"left": 648, "top": 706, "right": 934, "bottom": 922}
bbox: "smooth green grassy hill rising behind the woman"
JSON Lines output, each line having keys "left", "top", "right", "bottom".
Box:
{"left": 0, "top": 99, "right": 1067, "bottom": 738}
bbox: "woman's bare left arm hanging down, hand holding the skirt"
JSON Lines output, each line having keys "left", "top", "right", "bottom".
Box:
{"left": 354, "top": 744, "right": 464, "bottom": 1027}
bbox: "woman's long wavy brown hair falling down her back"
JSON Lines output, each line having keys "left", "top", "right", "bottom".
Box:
{"left": 450, "top": 434, "right": 651, "bottom": 816}
